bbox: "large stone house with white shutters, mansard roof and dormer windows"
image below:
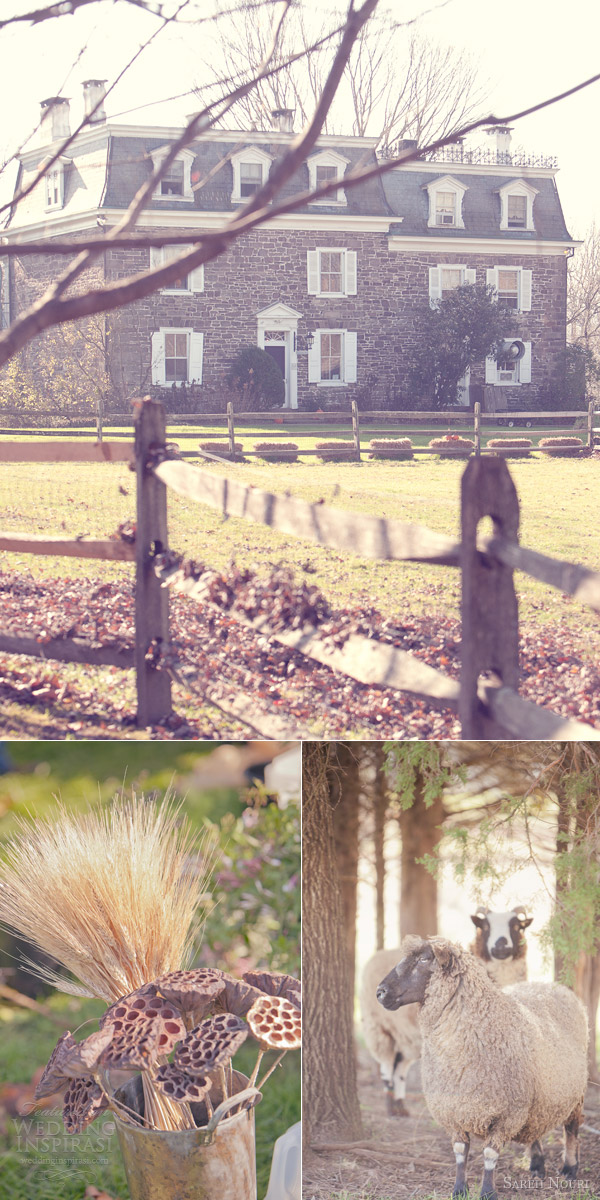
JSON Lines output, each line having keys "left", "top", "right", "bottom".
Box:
{"left": 2, "top": 80, "right": 575, "bottom": 412}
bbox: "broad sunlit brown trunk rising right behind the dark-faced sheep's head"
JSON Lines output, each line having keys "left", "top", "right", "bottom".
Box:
{"left": 398, "top": 779, "right": 444, "bottom": 940}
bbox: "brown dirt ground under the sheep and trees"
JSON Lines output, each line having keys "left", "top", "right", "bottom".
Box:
{"left": 302, "top": 1049, "right": 600, "bottom": 1200}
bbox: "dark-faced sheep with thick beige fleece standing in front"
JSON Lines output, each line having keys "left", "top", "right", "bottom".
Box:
{"left": 377, "top": 936, "right": 588, "bottom": 1200}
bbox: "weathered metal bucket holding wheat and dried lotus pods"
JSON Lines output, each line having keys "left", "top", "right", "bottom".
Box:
{"left": 115, "top": 1070, "right": 258, "bottom": 1200}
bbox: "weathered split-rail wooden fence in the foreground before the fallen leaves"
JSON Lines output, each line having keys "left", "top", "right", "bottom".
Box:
{"left": 0, "top": 400, "right": 600, "bottom": 740}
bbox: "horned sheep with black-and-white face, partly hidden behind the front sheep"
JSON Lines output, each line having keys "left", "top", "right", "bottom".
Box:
{"left": 360, "top": 907, "right": 533, "bottom": 1117}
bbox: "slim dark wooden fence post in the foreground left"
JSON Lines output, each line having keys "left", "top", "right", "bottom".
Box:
{"left": 134, "top": 398, "right": 172, "bottom": 728}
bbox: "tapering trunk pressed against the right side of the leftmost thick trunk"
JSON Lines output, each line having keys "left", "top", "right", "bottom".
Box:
{"left": 328, "top": 742, "right": 361, "bottom": 991}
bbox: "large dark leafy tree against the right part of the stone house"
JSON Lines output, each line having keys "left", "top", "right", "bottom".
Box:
{"left": 409, "top": 283, "right": 518, "bottom": 408}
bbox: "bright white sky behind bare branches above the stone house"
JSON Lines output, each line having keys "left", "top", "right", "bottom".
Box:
{"left": 0, "top": 0, "right": 600, "bottom": 238}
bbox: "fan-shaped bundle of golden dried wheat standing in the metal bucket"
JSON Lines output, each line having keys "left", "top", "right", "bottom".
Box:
{"left": 0, "top": 794, "right": 211, "bottom": 1129}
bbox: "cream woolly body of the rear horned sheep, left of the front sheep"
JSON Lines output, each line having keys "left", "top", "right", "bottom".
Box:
{"left": 360, "top": 949, "right": 421, "bottom": 1079}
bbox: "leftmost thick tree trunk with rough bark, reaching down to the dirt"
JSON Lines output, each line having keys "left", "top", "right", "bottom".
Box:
{"left": 302, "top": 742, "right": 361, "bottom": 1144}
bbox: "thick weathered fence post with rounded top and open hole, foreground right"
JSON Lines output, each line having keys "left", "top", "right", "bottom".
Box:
{"left": 458, "top": 455, "right": 518, "bottom": 738}
